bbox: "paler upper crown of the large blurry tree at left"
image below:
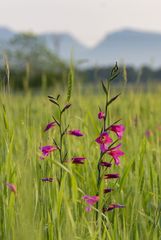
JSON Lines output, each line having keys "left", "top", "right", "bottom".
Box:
{"left": 7, "top": 33, "right": 65, "bottom": 72}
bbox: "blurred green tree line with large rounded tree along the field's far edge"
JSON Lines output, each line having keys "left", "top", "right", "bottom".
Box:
{"left": 0, "top": 33, "right": 161, "bottom": 89}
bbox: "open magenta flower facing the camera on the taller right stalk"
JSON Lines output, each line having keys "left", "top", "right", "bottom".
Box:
{"left": 95, "top": 132, "right": 112, "bottom": 152}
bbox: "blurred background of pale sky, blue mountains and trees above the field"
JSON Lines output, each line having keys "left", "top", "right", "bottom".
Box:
{"left": 0, "top": 0, "right": 161, "bottom": 90}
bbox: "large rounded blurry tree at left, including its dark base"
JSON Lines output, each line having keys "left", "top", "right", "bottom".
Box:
{"left": 1, "top": 33, "right": 68, "bottom": 88}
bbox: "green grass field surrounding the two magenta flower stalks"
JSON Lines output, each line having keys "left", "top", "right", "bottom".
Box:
{"left": 0, "top": 83, "right": 161, "bottom": 240}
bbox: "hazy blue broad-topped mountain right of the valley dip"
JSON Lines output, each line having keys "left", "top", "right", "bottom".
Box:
{"left": 90, "top": 30, "right": 161, "bottom": 66}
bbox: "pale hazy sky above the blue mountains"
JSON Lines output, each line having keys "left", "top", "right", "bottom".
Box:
{"left": 0, "top": 0, "right": 161, "bottom": 45}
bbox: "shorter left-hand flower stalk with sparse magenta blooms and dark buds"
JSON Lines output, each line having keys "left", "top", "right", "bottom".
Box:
{"left": 40, "top": 92, "right": 86, "bottom": 187}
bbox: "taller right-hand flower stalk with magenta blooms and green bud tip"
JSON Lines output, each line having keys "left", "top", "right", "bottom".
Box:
{"left": 87, "top": 62, "right": 125, "bottom": 224}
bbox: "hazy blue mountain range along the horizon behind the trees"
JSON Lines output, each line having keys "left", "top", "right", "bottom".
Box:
{"left": 0, "top": 28, "right": 161, "bottom": 67}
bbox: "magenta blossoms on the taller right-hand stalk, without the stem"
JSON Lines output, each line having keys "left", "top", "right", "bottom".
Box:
{"left": 82, "top": 111, "right": 125, "bottom": 212}
